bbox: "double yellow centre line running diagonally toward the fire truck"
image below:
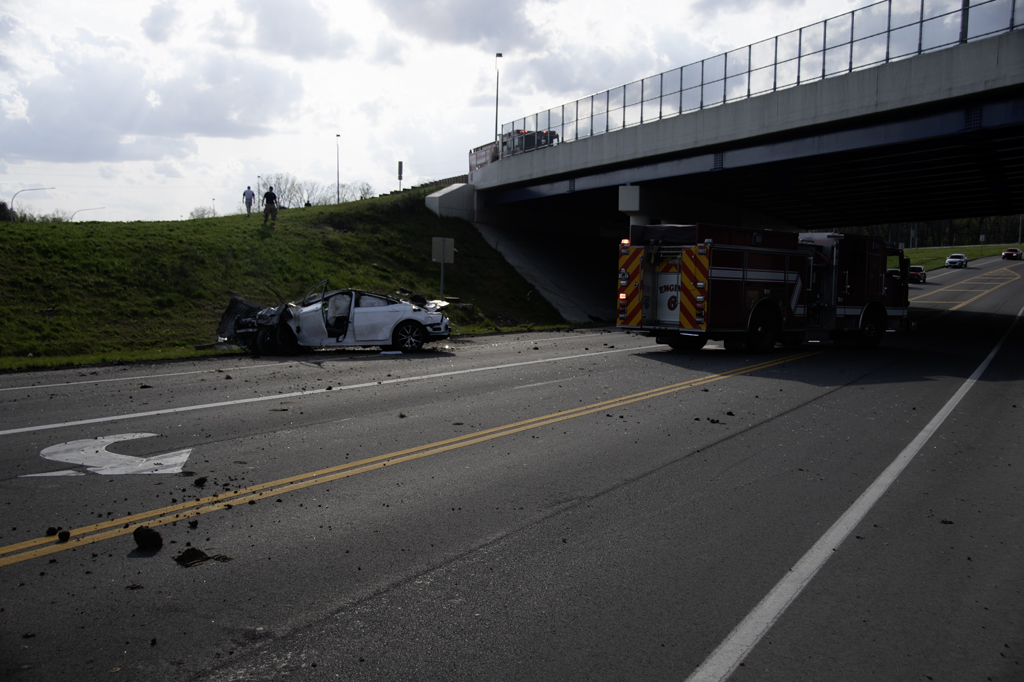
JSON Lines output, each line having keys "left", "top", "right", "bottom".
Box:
{"left": 0, "top": 350, "right": 819, "bottom": 566}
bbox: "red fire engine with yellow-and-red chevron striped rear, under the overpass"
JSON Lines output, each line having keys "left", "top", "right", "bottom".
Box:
{"left": 617, "top": 224, "right": 909, "bottom": 352}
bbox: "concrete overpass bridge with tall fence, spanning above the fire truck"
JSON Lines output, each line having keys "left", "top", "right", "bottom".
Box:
{"left": 428, "top": 0, "right": 1024, "bottom": 319}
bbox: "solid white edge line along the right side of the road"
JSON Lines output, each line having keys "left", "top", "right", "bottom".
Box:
{"left": 686, "top": 308, "right": 1024, "bottom": 682}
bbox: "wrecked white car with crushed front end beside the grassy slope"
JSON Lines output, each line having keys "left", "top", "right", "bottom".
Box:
{"left": 217, "top": 280, "right": 451, "bottom": 355}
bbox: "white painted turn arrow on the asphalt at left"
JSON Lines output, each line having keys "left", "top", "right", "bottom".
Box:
{"left": 22, "top": 433, "right": 191, "bottom": 478}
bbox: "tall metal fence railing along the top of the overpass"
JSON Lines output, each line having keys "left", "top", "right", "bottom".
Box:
{"left": 497, "top": 0, "right": 1024, "bottom": 158}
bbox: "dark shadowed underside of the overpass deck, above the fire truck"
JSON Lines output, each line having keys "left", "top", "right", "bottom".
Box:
{"left": 644, "top": 122, "right": 1024, "bottom": 229}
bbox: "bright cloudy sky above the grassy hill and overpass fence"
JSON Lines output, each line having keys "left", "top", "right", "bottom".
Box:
{"left": 0, "top": 0, "right": 867, "bottom": 220}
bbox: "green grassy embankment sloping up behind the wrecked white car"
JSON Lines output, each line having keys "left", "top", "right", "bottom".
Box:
{"left": 0, "top": 190, "right": 564, "bottom": 370}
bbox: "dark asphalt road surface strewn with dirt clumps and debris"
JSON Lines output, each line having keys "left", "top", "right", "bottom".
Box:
{"left": 0, "top": 259, "right": 1024, "bottom": 682}
